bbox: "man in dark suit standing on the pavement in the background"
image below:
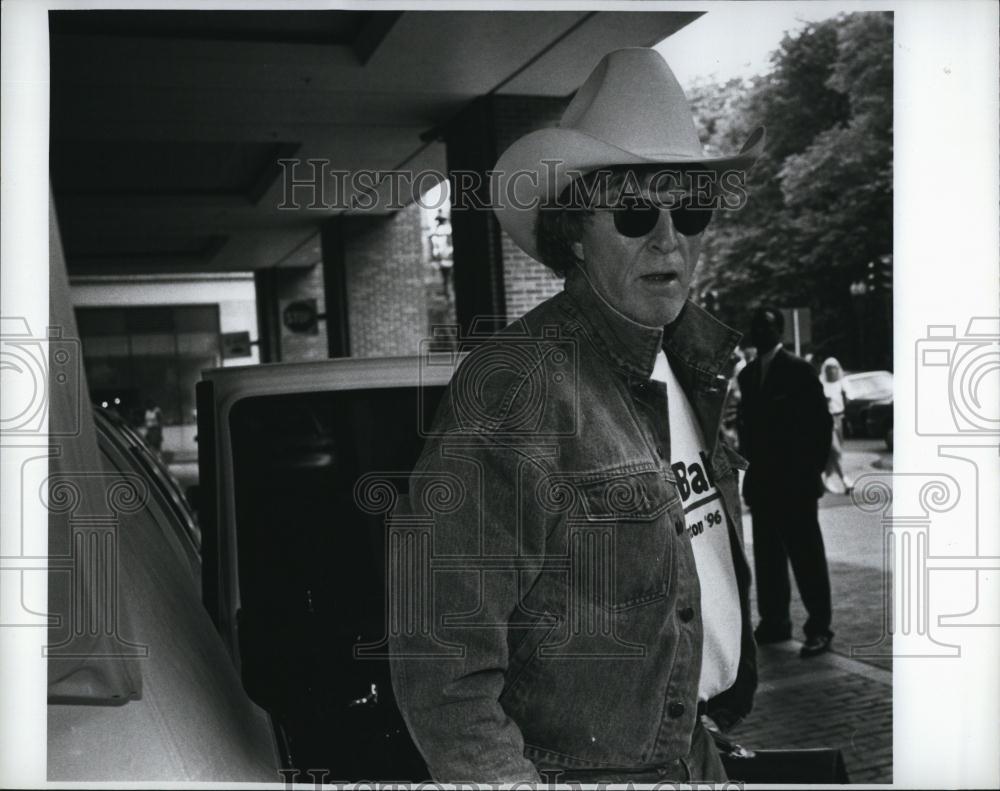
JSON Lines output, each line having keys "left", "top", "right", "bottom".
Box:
{"left": 739, "top": 308, "right": 833, "bottom": 657}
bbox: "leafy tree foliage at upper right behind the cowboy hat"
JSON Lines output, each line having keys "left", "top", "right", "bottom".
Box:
{"left": 689, "top": 12, "right": 892, "bottom": 365}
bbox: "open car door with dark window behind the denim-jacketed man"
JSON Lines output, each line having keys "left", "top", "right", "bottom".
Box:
{"left": 198, "top": 355, "right": 456, "bottom": 781}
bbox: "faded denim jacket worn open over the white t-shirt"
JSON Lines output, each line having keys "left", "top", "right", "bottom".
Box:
{"left": 390, "top": 274, "right": 757, "bottom": 783}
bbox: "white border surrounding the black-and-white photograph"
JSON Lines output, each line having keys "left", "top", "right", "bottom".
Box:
{"left": 0, "top": 0, "right": 1000, "bottom": 788}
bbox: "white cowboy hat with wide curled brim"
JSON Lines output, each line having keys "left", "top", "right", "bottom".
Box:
{"left": 491, "top": 47, "right": 764, "bottom": 260}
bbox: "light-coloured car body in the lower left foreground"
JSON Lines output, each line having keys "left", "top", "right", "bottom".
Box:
{"left": 48, "top": 410, "right": 281, "bottom": 782}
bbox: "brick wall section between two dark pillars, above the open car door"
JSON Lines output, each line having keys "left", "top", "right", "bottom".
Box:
{"left": 344, "top": 204, "right": 428, "bottom": 357}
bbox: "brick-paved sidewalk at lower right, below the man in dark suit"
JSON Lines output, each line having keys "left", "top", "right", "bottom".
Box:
{"left": 727, "top": 640, "right": 892, "bottom": 783}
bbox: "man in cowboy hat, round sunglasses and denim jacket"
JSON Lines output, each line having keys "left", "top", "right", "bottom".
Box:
{"left": 390, "top": 48, "right": 763, "bottom": 782}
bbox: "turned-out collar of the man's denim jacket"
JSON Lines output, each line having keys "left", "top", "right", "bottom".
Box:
{"left": 566, "top": 271, "right": 741, "bottom": 381}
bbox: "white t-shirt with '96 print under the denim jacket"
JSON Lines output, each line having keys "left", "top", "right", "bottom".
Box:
{"left": 652, "top": 350, "right": 742, "bottom": 700}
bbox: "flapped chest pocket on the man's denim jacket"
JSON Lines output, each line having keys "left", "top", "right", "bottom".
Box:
{"left": 544, "top": 469, "right": 683, "bottom": 610}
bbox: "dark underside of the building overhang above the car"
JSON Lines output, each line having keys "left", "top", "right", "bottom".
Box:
{"left": 50, "top": 10, "right": 700, "bottom": 275}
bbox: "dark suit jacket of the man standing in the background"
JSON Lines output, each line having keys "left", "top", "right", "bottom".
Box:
{"left": 739, "top": 349, "right": 833, "bottom": 501}
